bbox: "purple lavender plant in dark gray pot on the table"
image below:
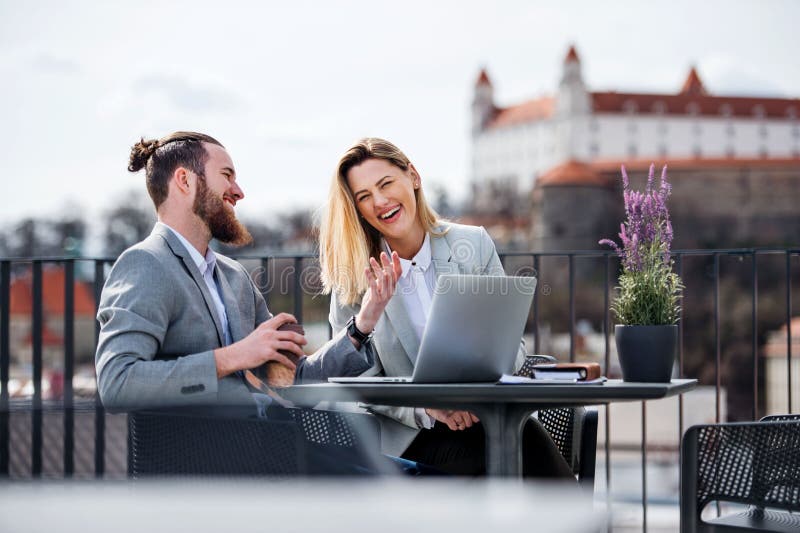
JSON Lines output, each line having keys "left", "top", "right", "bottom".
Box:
{"left": 600, "top": 165, "right": 683, "bottom": 383}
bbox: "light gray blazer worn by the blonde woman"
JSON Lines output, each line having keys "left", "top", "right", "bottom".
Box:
{"left": 329, "top": 223, "right": 525, "bottom": 456}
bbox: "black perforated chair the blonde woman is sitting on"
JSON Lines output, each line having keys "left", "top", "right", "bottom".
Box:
{"left": 517, "top": 355, "right": 597, "bottom": 490}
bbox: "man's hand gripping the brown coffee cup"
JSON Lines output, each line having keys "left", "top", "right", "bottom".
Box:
{"left": 214, "top": 313, "right": 306, "bottom": 378}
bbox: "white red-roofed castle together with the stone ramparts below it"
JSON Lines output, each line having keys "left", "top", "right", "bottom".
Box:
{"left": 471, "top": 47, "right": 800, "bottom": 250}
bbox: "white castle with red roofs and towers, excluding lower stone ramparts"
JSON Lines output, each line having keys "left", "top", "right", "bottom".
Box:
{"left": 472, "top": 47, "right": 800, "bottom": 186}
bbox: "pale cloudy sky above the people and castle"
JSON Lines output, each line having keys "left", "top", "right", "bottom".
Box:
{"left": 0, "top": 0, "right": 800, "bottom": 228}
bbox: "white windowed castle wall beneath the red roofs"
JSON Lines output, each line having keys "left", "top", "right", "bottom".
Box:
{"left": 472, "top": 113, "right": 800, "bottom": 187}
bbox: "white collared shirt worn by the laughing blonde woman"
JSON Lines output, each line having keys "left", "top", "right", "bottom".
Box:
{"left": 384, "top": 233, "right": 436, "bottom": 429}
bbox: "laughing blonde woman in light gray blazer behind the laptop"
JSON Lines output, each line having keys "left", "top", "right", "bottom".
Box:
{"left": 320, "top": 138, "right": 571, "bottom": 476}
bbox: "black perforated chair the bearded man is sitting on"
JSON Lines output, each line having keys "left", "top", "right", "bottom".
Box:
{"left": 128, "top": 406, "right": 391, "bottom": 479}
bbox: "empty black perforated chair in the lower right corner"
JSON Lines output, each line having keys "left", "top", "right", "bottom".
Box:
{"left": 681, "top": 415, "right": 800, "bottom": 533}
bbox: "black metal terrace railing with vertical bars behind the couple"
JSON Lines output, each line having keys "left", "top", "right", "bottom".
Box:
{"left": 0, "top": 248, "right": 800, "bottom": 531}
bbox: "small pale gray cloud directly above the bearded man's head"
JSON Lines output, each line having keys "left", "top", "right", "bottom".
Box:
{"left": 132, "top": 74, "right": 243, "bottom": 112}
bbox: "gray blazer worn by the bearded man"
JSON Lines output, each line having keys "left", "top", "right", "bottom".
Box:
{"left": 95, "top": 224, "right": 373, "bottom": 409}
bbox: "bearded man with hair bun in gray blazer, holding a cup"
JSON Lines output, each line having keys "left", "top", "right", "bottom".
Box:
{"left": 95, "top": 132, "right": 402, "bottom": 413}
